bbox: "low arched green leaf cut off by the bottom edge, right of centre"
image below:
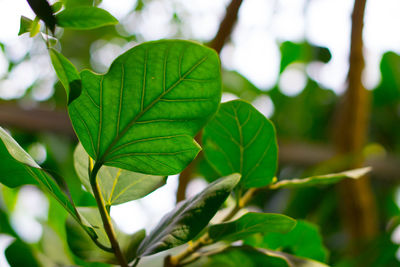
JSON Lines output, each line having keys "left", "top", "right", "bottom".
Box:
{"left": 189, "top": 246, "right": 291, "bottom": 267}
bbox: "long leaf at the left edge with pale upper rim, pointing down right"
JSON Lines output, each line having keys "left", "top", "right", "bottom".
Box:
{"left": 0, "top": 127, "right": 79, "bottom": 221}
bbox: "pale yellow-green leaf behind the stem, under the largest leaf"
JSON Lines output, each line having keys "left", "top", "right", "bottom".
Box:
{"left": 74, "top": 144, "right": 166, "bottom": 206}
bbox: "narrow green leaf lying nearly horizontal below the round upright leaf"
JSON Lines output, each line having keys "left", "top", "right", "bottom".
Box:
{"left": 208, "top": 212, "right": 296, "bottom": 242}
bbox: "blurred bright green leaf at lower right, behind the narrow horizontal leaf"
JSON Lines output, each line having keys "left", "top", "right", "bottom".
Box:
{"left": 245, "top": 220, "right": 328, "bottom": 262}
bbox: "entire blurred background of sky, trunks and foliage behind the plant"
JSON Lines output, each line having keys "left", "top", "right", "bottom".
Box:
{"left": 0, "top": 0, "right": 400, "bottom": 266}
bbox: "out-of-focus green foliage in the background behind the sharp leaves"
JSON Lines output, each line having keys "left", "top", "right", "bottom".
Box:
{"left": 0, "top": 0, "right": 400, "bottom": 267}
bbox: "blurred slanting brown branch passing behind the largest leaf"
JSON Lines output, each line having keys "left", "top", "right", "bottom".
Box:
{"left": 176, "top": 0, "right": 243, "bottom": 203}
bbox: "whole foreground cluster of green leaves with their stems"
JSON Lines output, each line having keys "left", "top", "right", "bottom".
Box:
{"left": 0, "top": 1, "right": 376, "bottom": 266}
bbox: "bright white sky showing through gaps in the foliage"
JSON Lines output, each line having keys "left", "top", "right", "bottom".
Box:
{"left": 0, "top": 0, "right": 400, "bottom": 266}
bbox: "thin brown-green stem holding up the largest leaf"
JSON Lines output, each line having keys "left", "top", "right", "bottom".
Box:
{"left": 90, "top": 162, "right": 129, "bottom": 267}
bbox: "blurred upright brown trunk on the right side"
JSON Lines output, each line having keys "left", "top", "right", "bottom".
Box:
{"left": 335, "top": 0, "right": 378, "bottom": 253}
